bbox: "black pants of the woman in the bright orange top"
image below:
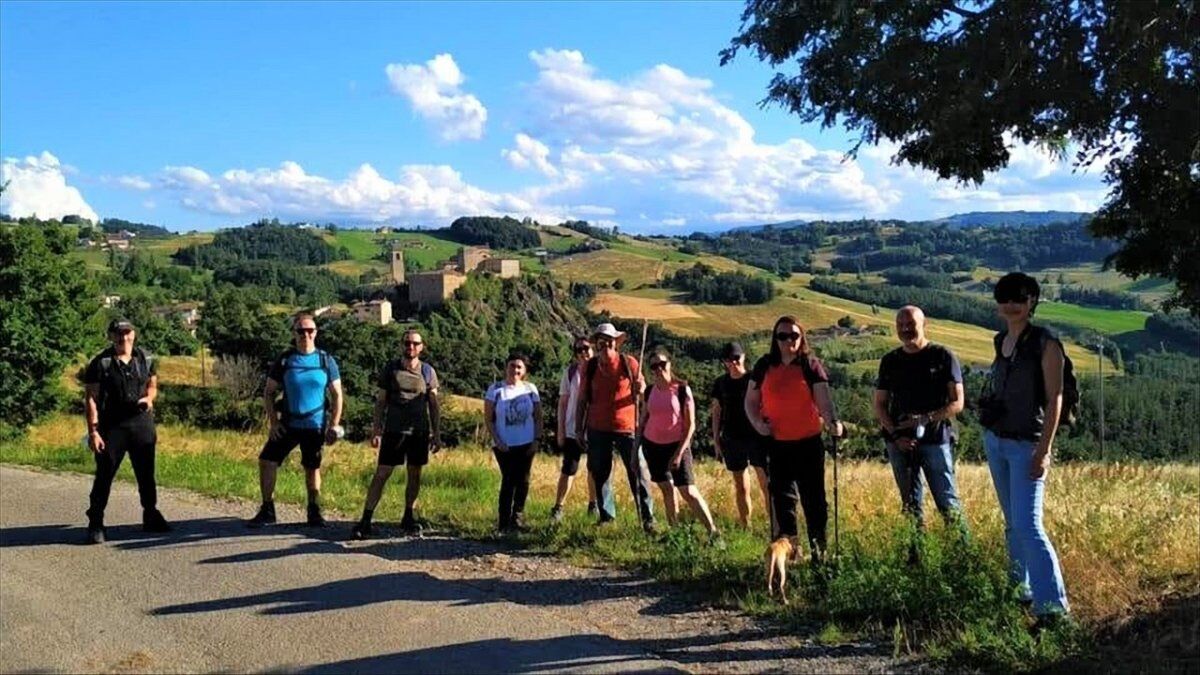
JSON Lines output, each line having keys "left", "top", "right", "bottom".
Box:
{"left": 767, "top": 435, "right": 829, "bottom": 550}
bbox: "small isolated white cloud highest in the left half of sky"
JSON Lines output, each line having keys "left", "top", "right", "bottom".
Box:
{"left": 384, "top": 54, "right": 487, "bottom": 141}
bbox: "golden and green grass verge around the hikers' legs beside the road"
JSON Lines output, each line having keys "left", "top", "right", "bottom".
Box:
{"left": 0, "top": 414, "right": 1200, "bottom": 668}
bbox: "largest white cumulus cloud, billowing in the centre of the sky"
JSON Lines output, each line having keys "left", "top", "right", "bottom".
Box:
{"left": 516, "top": 49, "right": 899, "bottom": 227}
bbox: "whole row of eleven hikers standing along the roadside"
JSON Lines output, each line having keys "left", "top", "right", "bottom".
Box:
{"left": 84, "top": 273, "right": 1075, "bottom": 617}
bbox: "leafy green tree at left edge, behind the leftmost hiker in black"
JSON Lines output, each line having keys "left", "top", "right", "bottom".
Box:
{"left": 0, "top": 226, "right": 103, "bottom": 436}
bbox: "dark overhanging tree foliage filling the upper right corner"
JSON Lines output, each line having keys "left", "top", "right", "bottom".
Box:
{"left": 721, "top": 0, "right": 1200, "bottom": 313}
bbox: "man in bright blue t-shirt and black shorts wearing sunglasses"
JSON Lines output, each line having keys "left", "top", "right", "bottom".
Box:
{"left": 248, "top": 313, "right": 342, "bottom": 527}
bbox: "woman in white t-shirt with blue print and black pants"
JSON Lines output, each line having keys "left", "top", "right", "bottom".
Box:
{"left": 484, "top": 354, "right": 541, "bottom": 532}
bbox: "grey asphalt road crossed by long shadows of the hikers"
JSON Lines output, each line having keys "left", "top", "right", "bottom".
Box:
{"left": 0, "top": 466, "right": 887, "bottom": 673}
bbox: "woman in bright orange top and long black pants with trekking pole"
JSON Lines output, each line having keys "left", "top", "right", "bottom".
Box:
{"left": 745, "top": 316, "right": 842, "bottom": 560}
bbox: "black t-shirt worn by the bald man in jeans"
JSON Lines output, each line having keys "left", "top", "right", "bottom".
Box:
{"left": 875, "top": 344, "right": 962, "bottom": 443}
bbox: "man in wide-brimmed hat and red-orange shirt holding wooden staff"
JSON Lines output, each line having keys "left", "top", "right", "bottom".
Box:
{"left": 576, "top": 323, "right": 654, "bottom": 532}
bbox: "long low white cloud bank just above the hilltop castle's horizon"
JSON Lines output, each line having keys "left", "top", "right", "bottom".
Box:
{"left": 147, "top": 157, "right": 539, "bottom": 225}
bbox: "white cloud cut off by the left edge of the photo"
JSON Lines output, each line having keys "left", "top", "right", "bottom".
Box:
{"left": 0, "top": 151, "right": 100, "bottom": 221}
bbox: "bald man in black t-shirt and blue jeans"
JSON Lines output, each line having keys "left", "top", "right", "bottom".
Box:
{"left": 875, "top": 305, "right": 964, "bottom": 535}
